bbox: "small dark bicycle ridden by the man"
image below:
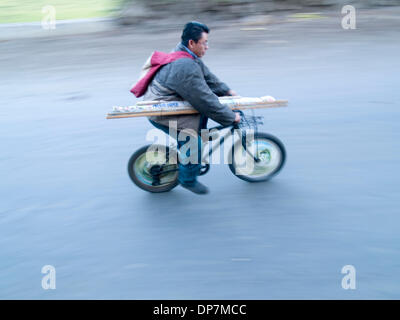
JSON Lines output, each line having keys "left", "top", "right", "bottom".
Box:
{"left": 128, "top": 110, "right": 286, "bottom": 193}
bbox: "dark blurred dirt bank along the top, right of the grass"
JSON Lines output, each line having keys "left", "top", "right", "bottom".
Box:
{"left": 118, "top": 0, "right": 400, "bottom": 25}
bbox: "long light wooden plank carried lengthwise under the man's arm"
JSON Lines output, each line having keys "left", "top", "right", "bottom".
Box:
{"left": 107, "top": 100, "right": 288, "bottom": 119}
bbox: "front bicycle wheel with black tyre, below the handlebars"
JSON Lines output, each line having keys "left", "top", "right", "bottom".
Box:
{"left": 229, "top": 132, "right": 286, "bottom": 182}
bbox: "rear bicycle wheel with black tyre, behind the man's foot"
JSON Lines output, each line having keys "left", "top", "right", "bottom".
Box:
{"left": 128, "top": 145, "right": 178, "bottom": 193}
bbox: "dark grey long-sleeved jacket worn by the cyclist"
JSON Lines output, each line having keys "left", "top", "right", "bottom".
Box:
{"left": 143, "top": 44, "right": 235, "bottom": 132}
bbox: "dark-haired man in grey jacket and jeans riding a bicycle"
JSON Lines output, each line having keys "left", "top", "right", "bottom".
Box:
{"left": 132, "top": 21, "right": 240, "bottom": 194}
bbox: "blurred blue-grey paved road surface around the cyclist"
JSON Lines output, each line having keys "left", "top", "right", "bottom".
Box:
{"left": 0, "top": 11, "right": 400, "bottom": 299}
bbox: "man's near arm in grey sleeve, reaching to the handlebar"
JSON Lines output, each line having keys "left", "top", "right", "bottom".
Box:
{"left": 167, "top": 59, "right": 236, "bottom": 125}
